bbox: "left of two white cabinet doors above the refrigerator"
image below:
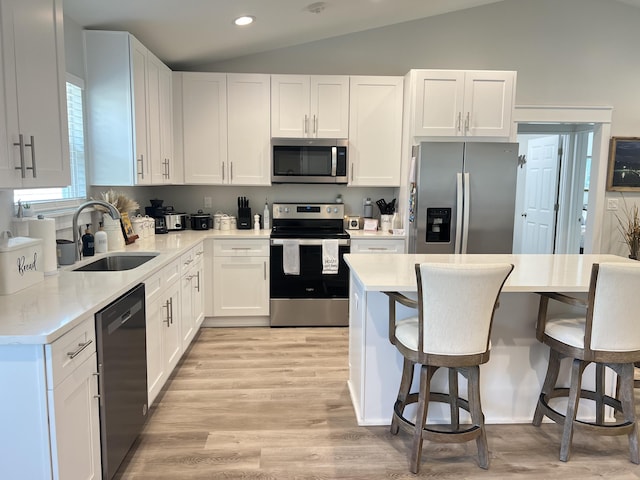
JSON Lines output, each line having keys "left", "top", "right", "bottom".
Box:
{"left": 413, "top": 70, "right": 465, "bottom": 137}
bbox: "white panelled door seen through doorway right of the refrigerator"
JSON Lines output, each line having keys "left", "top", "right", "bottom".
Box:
{"left": 521, "top": 135, "right": 560, "bottom": 253}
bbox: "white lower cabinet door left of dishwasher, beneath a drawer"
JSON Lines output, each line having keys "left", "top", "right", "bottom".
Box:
{"left": 48, "top": 352, "right": 102, "bottom": 480}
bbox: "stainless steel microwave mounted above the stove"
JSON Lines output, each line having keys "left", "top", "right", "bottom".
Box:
{"left": 271, "top": 138, "right": 348, "bottom": 184}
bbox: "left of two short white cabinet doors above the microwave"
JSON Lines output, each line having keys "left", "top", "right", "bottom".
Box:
{"left": 271, "top": 75, "right": 311, "bottom": 138}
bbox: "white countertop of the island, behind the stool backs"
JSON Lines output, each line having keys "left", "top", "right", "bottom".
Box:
{"left": 345, "top": 253, "right": 633, "bottom": 292}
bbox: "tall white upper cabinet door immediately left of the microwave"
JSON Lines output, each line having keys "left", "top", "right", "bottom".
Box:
{"left": 227, "top": 74, "right": 271, "bottom": 185}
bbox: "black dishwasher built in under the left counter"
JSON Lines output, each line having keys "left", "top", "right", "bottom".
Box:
{"left": 96, "top": 283, "right": 147, "bottom": 480}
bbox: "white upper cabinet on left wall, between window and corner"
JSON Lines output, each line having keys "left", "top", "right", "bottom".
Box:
{"left": 84, "top": 30, "right": 179, "bottom": 185}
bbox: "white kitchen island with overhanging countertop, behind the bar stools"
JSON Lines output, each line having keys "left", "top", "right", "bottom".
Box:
{"left": 345, "top": 254, "right": 632, "bottom": 425}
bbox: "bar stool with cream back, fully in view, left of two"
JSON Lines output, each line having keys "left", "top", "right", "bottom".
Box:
{"left": 386, "top": 263, "right": 513, "bottom": 473}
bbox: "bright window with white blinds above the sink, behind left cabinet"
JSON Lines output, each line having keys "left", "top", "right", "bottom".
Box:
{"left": 13, "top": 75, "right": 87, "bottom": 209}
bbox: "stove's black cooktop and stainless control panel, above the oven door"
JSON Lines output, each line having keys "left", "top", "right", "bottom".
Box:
{"left": 271, "top": 203, "right": 349, "bottom": 239}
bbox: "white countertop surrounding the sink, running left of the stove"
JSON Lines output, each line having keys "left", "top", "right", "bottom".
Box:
{"left": 0, "top": 230, "right": 270, "bottom": 345}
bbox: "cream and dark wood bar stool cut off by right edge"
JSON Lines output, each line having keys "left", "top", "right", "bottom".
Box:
{"left": 533, "top": 263, "right": 640, "bottom": 463}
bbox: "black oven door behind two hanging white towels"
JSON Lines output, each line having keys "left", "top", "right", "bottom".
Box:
{"left": 270, "top": 238, "right": 350, "bottom": 299}
